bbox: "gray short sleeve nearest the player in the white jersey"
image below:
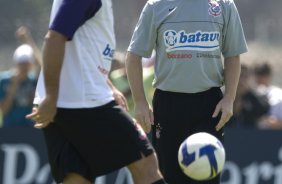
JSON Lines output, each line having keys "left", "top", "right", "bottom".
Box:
{"left": 128, "top": 2, "right": 157, "bottom": 57}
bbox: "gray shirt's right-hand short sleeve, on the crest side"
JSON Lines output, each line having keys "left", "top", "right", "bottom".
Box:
{"left": 222, "top": 0, "right": 248, "bottom": 58}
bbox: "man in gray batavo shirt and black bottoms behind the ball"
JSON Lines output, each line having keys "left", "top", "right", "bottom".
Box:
{"left": 126, "top": 0, "right": 247, "bottom": 184}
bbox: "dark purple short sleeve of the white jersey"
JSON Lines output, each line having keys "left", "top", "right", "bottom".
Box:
{"left": 49, "top": 0, "right": 102, "bottom": 40}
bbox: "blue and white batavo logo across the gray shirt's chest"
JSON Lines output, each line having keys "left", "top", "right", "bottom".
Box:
{"left": 163, "top": 30, "right": 220, "bottom": 52}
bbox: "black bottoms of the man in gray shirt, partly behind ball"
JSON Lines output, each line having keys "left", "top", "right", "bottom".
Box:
{"left": 152, "top": 88, "right": 223, "bottom": 184}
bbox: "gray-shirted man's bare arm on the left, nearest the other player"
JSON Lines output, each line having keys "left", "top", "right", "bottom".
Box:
{"left": 125, "top": 52, "right": 154, "bottom": 133}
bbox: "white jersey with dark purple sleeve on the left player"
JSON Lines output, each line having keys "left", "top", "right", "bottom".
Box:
{"left": 34, "top": 0, "right": 115, "bottom": 108}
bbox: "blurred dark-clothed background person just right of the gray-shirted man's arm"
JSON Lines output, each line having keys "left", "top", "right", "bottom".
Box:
{"left": 227, "top": 64, "right": 269, "bottom": 128}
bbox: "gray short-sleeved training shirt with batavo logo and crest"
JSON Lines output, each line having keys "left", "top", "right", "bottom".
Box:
{"left": 128, "top": 0, "right": 247, "bottom": 93}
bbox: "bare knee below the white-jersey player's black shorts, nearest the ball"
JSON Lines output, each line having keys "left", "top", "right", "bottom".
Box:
{"left": 128, "top": 153, "right": 163, "bottom": 184}
